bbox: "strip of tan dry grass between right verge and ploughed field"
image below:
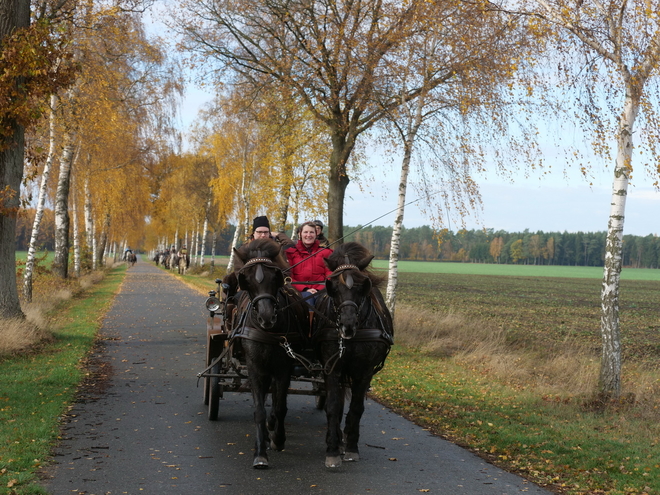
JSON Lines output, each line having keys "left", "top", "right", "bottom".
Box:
{"left": 394, "top": 305, "right": 660, "bottom": 416}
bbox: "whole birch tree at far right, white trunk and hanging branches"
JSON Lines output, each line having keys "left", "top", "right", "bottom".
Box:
{"left": 525, "top": 0, "right": 660, "bottom": 399}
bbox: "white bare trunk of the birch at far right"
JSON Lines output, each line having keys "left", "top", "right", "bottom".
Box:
{"left": 599, "top": 88, "right": 639, "bottom": 397}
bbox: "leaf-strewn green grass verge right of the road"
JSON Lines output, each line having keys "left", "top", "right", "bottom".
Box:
{"left": 373, "top": 346, "right": 660, "bottom": 495}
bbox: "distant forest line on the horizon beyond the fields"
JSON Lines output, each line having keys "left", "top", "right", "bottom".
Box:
{"left": 16, "top": 210, "right": 660, "bottom": 268}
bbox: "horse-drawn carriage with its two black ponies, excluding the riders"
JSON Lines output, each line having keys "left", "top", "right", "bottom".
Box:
{"left": 198, "top": 239, "right": 393, "bottom": 468}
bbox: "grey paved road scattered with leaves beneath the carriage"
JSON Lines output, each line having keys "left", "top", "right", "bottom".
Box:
{"left": 45, "top": 260, "right": 549, "bottom": 495}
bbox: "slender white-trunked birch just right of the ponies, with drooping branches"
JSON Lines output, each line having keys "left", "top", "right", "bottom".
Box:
{"left": 384, "top": 8, "right": 538, "bottom": 313}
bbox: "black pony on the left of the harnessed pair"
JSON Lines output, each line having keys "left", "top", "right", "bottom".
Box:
{"left": 232, "top": 239, "right": 309, "bottom": 469}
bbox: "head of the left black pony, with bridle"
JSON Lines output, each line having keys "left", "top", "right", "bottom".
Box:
{"left": 234, "top": 239, "right": 287, "bottom": 330}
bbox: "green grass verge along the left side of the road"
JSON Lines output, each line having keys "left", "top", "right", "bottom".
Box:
{"left": 0, "top": 265, "right": 125, "bottom": 495}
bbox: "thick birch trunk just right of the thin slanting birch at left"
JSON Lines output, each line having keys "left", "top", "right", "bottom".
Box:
{"left": 53, "top": 134, "right": 75, "bottom": 279}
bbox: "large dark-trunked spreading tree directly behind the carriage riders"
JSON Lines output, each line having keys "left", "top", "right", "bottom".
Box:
{"left": 178, "top": 0, "right": 453, "bottom": 241}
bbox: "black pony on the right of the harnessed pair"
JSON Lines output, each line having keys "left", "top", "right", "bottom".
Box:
{"left": 312, "top": 242, "right": 394, "bottom": 468}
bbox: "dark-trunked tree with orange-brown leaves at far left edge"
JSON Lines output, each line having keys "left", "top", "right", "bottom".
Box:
{"left": 0, "top": 0, "right": 71, "bottom": 318}
